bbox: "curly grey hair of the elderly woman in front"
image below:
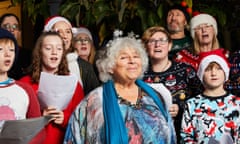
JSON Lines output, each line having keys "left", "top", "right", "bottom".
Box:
{"left": 96, "top": 37, "right": 148, "bottom": 82}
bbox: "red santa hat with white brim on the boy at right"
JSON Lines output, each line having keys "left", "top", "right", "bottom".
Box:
{"left": 197, "top": 49, "right": 230, "bottom": 81}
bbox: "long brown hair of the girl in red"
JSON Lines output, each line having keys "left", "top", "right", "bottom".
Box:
{"left": 31, "top": 31, "right": 69, "bottom": 83}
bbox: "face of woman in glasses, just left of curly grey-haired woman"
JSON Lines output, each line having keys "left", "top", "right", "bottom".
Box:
{"left": 73, "top": 33, "right": 92, "bottom": 60}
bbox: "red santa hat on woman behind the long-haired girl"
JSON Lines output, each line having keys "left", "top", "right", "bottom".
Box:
{"left": 43, "top": 16, "right": 72, "bottom": 31}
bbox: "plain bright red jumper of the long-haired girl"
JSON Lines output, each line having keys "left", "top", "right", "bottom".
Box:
{"left": 20, "top": 76, "right": 84, "bottom": 144}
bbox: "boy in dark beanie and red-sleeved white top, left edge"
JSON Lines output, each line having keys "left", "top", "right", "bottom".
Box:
{"left": 0, "top": 28, "right": 41, "bottom": 143}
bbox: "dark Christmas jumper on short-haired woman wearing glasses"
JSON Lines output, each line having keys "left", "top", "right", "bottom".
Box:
{"left": 143, "top": 61, "right": 203, "bottom": 143}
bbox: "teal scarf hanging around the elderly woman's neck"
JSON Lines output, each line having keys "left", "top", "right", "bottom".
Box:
{"left": 103, "top": 80, "right": 175, "bottom": 144}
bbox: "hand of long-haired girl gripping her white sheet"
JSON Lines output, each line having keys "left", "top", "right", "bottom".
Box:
{"left": 43, "top": 106, "right": 64, "bottom": 124}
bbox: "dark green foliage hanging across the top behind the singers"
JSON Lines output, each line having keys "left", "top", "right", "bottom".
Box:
{"left": 12, "top": 0, "right": 240, "bottom": 50}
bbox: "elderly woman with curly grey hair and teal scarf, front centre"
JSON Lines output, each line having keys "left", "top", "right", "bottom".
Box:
{"left": 64, "top": 31, "right": 176, "bottom": 144}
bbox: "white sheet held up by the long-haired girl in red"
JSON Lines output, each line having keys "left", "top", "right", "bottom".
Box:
{"left": 38, "top": 72, "right": 78, "bottom": 110}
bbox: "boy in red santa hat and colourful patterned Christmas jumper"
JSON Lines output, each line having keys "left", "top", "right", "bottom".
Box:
{"left": 181, "top": 49, "right": 240, "bottom": 144}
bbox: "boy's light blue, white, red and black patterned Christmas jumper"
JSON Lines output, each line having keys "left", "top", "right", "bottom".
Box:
{"left": 181, "top": 93, "right": 240, "bottom": 144}
